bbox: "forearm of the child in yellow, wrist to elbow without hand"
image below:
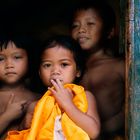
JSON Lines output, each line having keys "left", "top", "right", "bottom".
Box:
{"left": 65, "top": 104, "right": 100, "bottom": 139}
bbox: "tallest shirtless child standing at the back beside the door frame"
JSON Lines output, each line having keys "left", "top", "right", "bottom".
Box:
{"left": 71, "top": 1, "right": 125, "bottom": 140}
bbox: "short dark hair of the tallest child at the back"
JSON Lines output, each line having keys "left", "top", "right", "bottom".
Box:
{"left": 71, "top": 0, "right": 116, "bottom": 37}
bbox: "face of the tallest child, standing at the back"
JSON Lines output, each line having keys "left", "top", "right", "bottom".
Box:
{"left": 72, "top": 9, "right": 103, "bottom": 50}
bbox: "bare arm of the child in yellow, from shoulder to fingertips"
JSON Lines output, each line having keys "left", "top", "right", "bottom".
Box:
{"left": 50, "top": 80, "right": 100, "bottom": 139}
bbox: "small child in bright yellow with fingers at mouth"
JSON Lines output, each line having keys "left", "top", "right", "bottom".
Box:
{"left": 6, "top": 36, "right": 100, "bottom": 140}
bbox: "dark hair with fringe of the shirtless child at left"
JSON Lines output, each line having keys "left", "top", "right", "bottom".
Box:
{"left": 0, "top": 34, "right": 38, "bottom": 87}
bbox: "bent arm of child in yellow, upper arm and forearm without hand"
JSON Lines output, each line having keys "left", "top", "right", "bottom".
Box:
{"left": 65, "top": 92, "right": 100, "bottom": 139}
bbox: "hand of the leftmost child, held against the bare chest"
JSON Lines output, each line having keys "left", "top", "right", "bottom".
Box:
{"left": 4, "top": 94, "right": 27, "bottom": 120}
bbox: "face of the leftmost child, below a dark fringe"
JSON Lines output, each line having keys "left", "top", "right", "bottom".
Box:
{"left": 0, "top": 42, "right": 28, "bottom": 84}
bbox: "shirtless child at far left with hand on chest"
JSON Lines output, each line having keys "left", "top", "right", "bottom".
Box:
{"left": 0, "top": 34, "right": 40, "bottom": 140}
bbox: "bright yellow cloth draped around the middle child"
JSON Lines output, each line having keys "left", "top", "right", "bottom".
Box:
{"left": 6, "top": 84, "right": 90, "bottom": 140}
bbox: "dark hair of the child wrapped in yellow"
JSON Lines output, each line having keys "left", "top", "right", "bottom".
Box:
{"left": 40, "top": 35, "right": 85, "bottom": 82}
